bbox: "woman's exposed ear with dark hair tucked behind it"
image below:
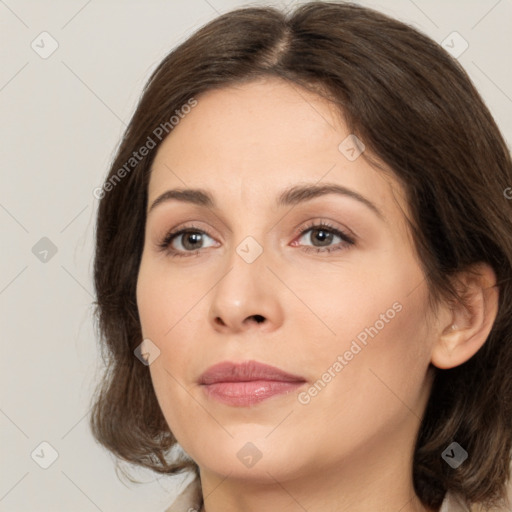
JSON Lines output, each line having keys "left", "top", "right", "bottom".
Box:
{"left": 431, "top": 263, "right": 499, "bottom": 369}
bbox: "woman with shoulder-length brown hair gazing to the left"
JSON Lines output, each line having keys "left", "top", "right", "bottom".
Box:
{"left": 91, "top": 2, "right": 512, "bottom": 512}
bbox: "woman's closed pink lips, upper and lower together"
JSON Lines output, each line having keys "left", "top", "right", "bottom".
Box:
{"left": 199, "top": 361, "right": 306, "bottom": 407}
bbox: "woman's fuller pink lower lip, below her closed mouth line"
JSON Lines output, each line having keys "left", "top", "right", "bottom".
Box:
{"left": 202, "top": 380, "right": 304, "bottom": 407}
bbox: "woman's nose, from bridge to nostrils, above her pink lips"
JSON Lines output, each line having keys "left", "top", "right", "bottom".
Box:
{"left": 209, "top": 241, "right": 283, "bottom": 333}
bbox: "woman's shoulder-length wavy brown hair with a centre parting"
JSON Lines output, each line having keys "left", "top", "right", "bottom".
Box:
{"left": 90, "top": 2, "right": 512, "bottom": 507}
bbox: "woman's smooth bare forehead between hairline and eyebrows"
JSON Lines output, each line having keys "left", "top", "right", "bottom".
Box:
{"left": 148, "top": 78, "right": 405, "bottom": 220}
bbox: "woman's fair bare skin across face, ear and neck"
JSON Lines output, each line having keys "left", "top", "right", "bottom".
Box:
{"left": 137, "top": 79, "right": 496, "bottom": 512}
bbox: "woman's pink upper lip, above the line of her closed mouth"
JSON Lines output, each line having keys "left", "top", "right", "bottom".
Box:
{"left": 199, "top": 361, "right": 305, "bottom": 384}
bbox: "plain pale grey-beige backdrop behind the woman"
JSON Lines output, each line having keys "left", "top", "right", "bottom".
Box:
{"left": 0, "top": 0, "right": 512, "bottom": 512}
